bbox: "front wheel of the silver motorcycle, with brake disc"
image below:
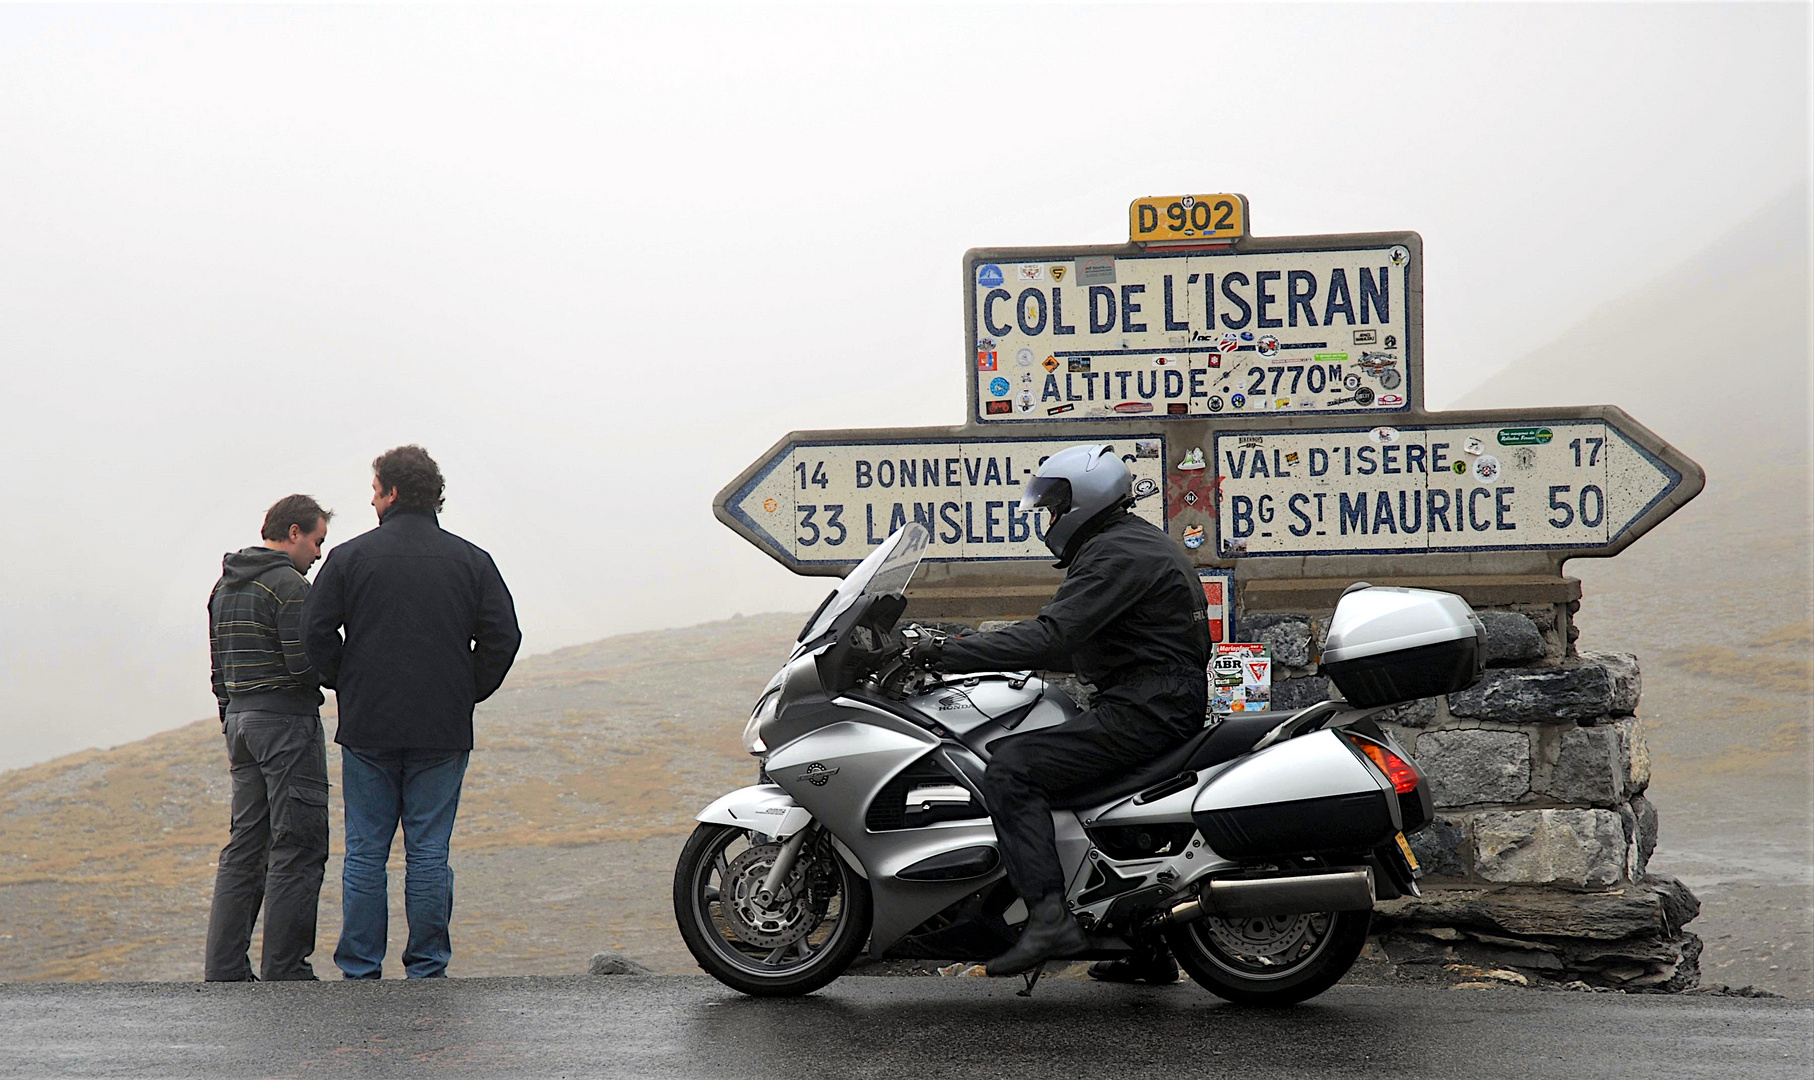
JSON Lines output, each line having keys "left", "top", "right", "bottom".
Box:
{"left": 675, "top": 824, "right": 871, "bottom": 997}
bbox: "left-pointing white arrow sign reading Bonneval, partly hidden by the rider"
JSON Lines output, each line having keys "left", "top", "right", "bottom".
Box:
{"left": 713, "top": 428, "right": 1166, "bottom": 574}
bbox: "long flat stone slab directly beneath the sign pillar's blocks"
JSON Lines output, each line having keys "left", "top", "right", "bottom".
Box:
{"left": 1373, "top": 882, "right": 1700, "bottom": 947}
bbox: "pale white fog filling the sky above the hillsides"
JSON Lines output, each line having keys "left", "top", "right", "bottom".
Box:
{"left": 0, "top": 4, "right": 1809, "bottom": 768}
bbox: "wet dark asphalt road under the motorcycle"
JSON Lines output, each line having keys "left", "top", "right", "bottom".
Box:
{"left": 0, "top": 977, "right": 1814, "bottom": 1080}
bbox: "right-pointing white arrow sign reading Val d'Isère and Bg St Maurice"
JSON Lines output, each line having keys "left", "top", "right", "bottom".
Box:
{"left": 1215, "top": 408, "right": 1703, "bottom": 557}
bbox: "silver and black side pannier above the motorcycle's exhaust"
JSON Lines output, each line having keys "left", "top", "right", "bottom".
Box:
{"left": 1190, "top": 731, "right": 1400, "bottom": 859}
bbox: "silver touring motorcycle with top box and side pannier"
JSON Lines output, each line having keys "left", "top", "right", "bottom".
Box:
{"left": 673, "top": 523, "right": 1486, "bottom": 1006}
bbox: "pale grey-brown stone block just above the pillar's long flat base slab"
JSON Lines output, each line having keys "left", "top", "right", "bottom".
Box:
{"left": 1473, "top": 810, "right": 1625, "bottom": 889}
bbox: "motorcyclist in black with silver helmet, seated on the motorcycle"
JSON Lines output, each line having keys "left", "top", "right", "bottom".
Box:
{"left": 912, "top": 447, "right": 1210, "bottom": 982}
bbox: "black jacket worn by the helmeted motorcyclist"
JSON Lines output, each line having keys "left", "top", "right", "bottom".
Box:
{"left": 940, "top": 512, "right": 1210, "bottom": 730}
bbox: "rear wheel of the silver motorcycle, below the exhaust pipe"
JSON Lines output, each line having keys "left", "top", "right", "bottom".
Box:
{"left": 1165, "top": 911, "right": 1373, "bottom": 1006}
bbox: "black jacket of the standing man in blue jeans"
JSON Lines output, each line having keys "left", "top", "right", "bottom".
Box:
{"left": 303, "top": 508, "right": 522, "bottom": 750}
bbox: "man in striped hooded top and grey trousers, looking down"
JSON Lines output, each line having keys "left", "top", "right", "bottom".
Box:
{"left": 203, "top": 496, "right": 334, "bottom": 982}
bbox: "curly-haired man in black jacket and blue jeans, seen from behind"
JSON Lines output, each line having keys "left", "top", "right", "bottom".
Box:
{"left": 303, "top": 447, "right": 522, "bottom": 978}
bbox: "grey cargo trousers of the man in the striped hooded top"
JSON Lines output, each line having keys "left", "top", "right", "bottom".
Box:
{"left": 203, "top": 712, "right": 328, "bottom": 982}
